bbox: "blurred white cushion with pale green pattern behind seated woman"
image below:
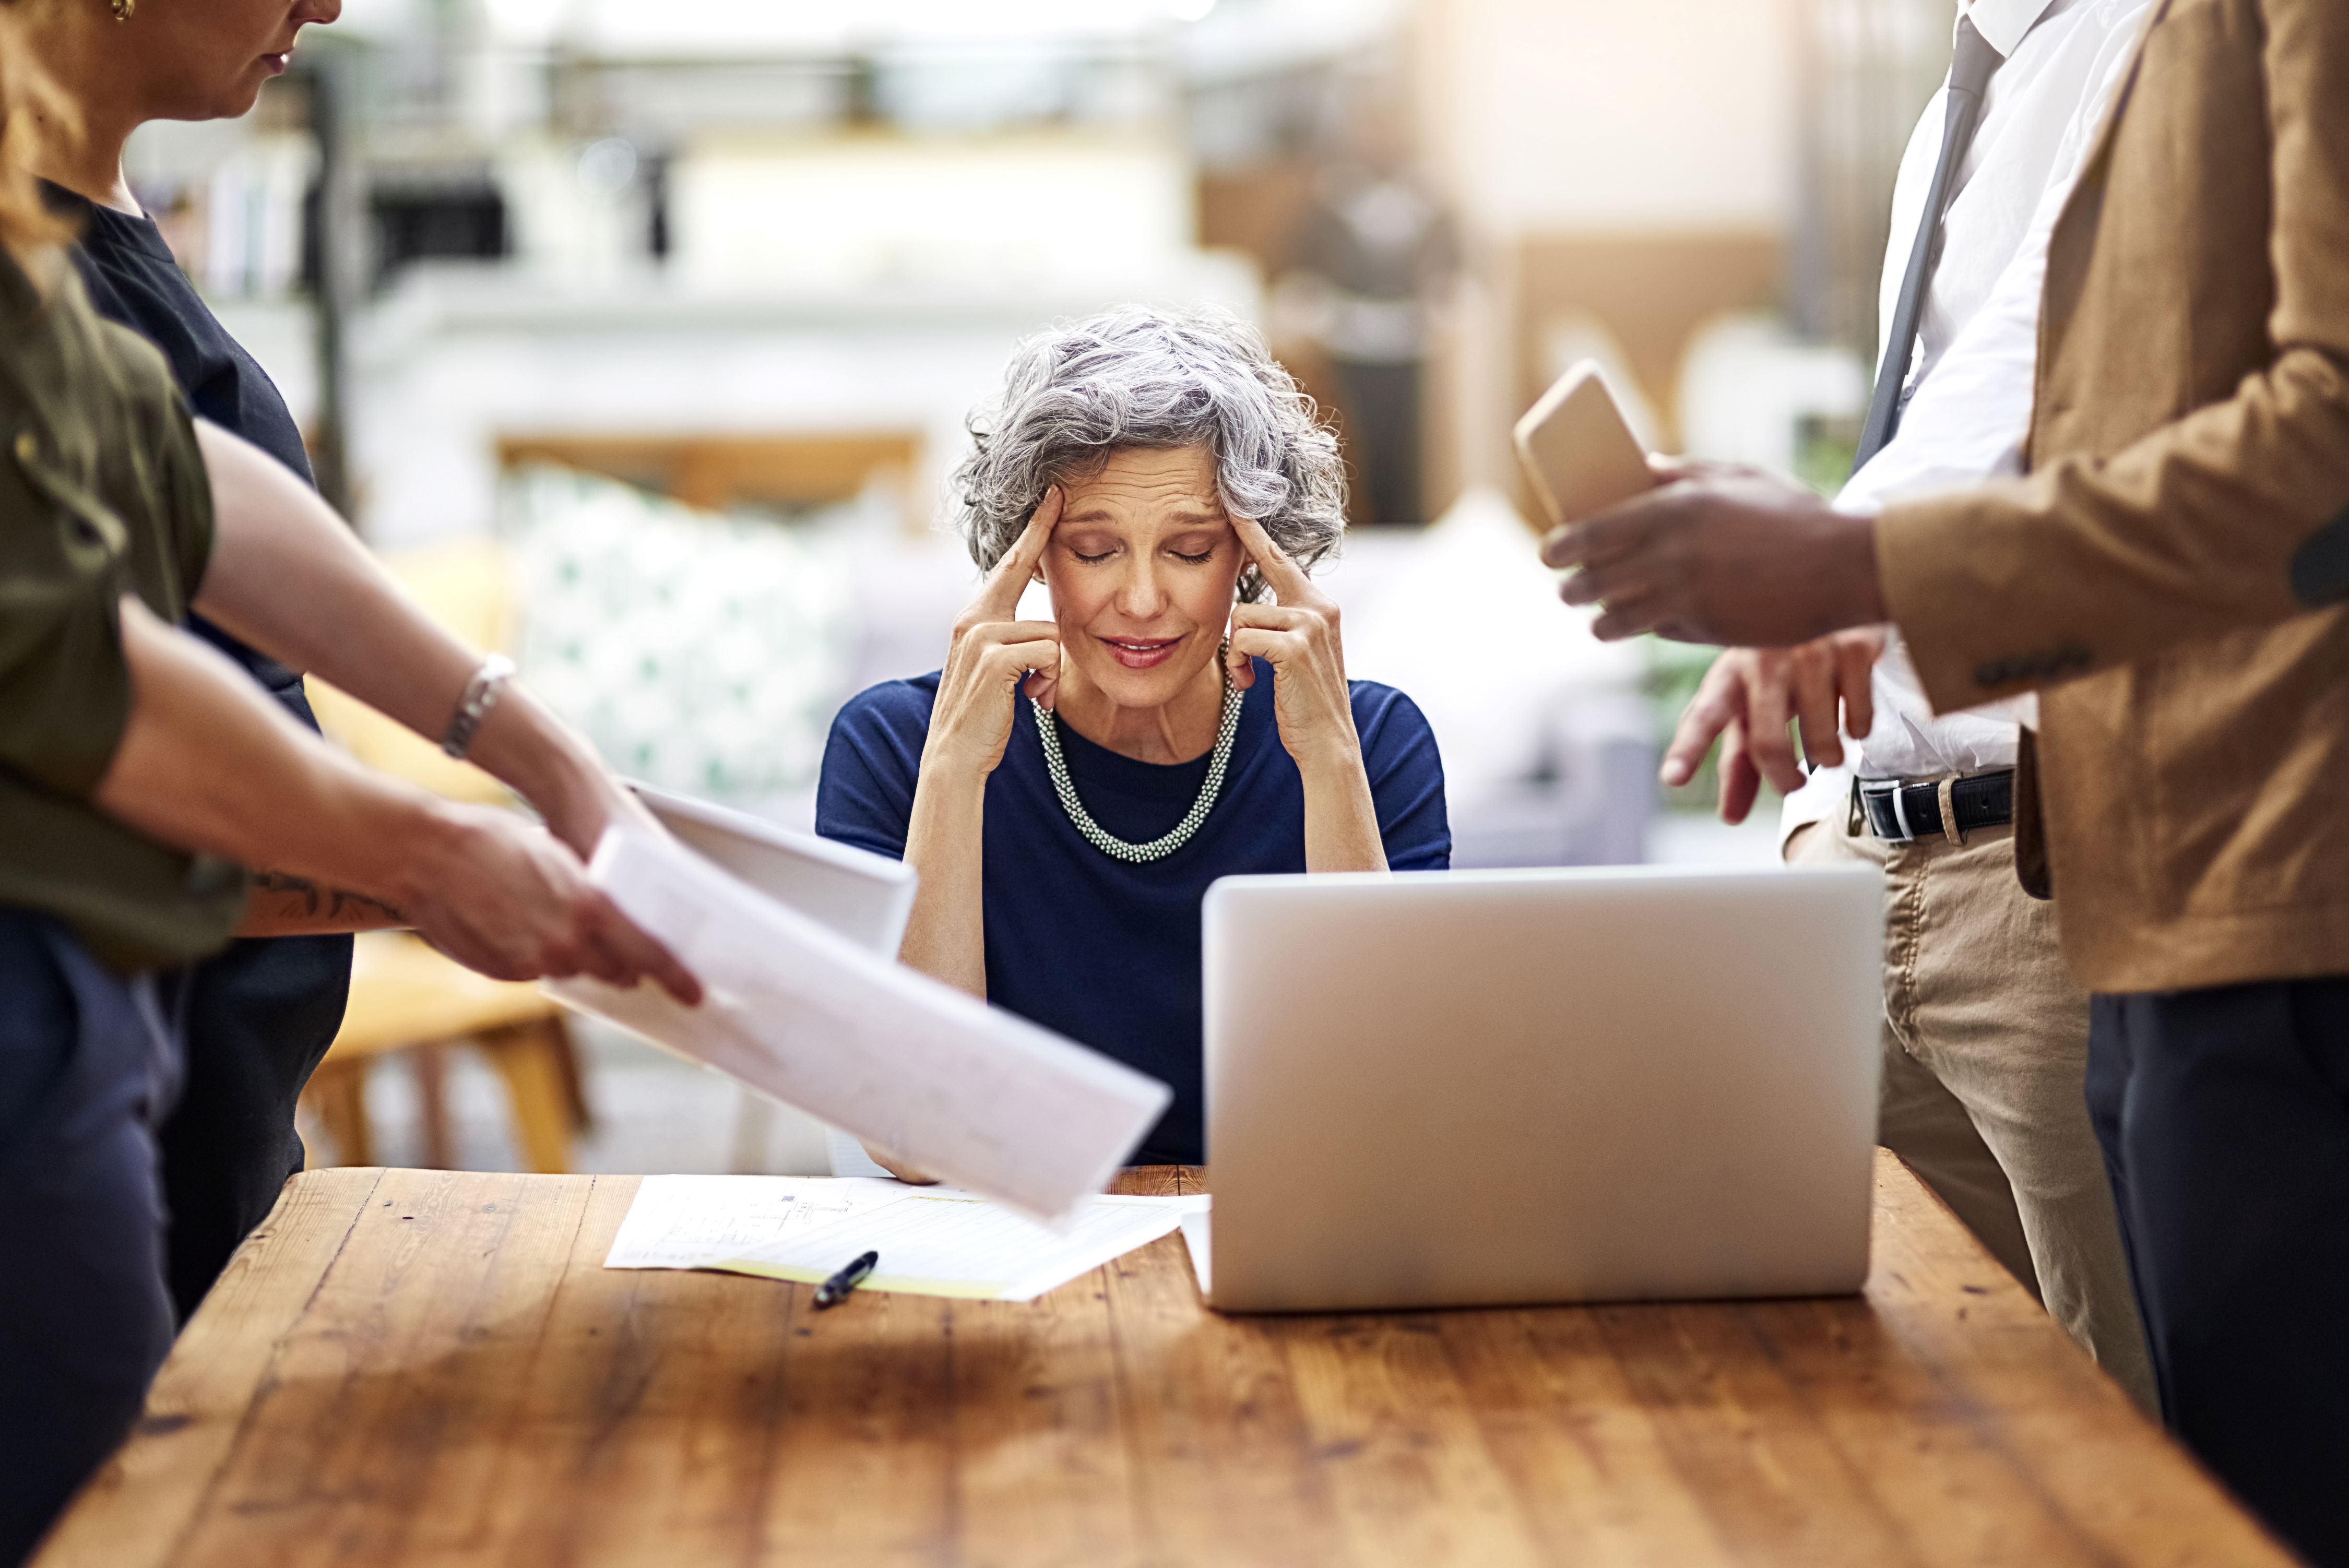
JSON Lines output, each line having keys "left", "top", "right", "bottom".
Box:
{"left": 501, "top": 467, "right": 855, "bottom": 807}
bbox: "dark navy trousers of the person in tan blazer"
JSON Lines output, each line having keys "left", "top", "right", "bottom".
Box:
{"left": 2089, "top": 979, "right": 2349, "bottom": 1568}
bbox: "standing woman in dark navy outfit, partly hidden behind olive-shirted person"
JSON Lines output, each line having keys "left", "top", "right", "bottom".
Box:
{"left": 9, "top": 0, "right": 350, "bottom": 1322}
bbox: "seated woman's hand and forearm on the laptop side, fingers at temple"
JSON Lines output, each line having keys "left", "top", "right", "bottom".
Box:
{"left": 1226, "top": 516, "right": 1386, "bottom": 871}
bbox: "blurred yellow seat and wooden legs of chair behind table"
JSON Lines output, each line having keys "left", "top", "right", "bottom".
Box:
{"left": 303, "top": 932, "right": 587, "bottom": 1176}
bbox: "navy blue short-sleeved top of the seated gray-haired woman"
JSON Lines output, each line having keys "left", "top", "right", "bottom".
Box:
{"left": 815, "top": 660, "right": 1452, "bottom": 1165}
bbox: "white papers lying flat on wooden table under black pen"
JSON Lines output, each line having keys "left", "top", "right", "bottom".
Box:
{"left": 604, "top": 1176, "right": 1205, "bottom": 1300}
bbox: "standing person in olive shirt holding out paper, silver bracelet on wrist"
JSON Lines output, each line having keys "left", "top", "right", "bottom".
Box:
{"left": 0, "top": 43, "right": 700, "bottom": 1568}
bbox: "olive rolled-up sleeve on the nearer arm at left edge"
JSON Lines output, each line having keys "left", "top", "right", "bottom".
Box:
{"left": 0, "top": 450, "right": 132, "bottom": 798}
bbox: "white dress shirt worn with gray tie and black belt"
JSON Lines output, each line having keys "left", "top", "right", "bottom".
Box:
{"left": 1783, "top": 0, "right": 2152, "bottom": 833}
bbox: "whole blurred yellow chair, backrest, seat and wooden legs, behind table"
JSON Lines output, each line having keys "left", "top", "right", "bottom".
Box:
{"left": 303, "top": 540, "right": 587, "bottom": 1174}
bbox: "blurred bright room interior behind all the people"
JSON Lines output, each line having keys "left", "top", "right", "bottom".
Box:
{"left": 129, "top": 0, "right": 1954, "bottom": 1171}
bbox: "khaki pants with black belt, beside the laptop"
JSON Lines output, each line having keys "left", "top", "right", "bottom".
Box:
{"left": 1788, "top": 812, "right": 2156, "bottom": 1413}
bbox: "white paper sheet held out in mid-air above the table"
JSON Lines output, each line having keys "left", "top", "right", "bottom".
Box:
{"left": 548, "top": 828, "right": 1172, "bottom": 1218}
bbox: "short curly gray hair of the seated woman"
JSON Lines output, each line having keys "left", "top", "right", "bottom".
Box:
{"left": 954, "top": 305, "right": 1346, "bottom": 601}
